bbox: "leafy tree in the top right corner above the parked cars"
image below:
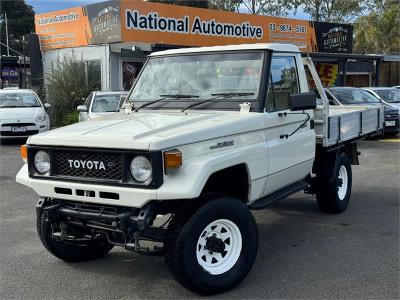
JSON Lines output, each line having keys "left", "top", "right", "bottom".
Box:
{"left": 354, "top": 1, "right": 400, "bottom": 54}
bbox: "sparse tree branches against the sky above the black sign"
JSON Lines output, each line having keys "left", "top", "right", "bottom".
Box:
{"left": 295, "top": 0, "right": 378, "bottom": 23}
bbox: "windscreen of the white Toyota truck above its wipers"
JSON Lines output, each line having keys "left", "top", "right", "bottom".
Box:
{"left": 128, "top": 52, "right": 262, "bottom": 107}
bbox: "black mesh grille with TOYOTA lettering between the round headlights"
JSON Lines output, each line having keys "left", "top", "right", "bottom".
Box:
{"left": 52, "top": 150, "right": 122, "bottom": 181}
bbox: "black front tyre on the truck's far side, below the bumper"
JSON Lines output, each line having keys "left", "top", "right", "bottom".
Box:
{"left": 37, "top": 209, "right": 113, "bottom": 262}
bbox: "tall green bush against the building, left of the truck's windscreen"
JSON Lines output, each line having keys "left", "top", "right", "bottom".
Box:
{"left": 46, "top": 55, "right": 94, "bottom": 126}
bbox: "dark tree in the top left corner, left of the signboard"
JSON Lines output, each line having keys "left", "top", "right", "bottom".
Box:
{"left": 0, "top": 0, "right": 35, "bottom": 55}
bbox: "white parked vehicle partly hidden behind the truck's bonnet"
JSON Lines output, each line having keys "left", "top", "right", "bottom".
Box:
{"left": 77, "top": 91, "right": 128, "bottom": 122}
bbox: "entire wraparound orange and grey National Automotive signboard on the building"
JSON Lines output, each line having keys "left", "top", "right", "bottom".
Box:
{"left": 35, "top": 0, "right": 317, "bottom": 52}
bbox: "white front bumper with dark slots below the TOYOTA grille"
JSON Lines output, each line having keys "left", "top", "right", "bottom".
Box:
{"left": 16, "top": 164, "right": 157, "bottom": 208}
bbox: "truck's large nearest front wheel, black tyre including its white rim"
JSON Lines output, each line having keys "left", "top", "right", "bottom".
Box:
{"left": 165, "top": 197, "right": 258, "bottom": 295}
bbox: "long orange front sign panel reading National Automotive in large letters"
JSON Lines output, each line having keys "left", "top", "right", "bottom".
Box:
{"left": 121, "top": 1, "right": 316, "bottom": 52}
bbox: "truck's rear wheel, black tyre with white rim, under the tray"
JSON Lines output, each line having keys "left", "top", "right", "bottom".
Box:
{"left": 316, "top": 153, "right": 352, "bottom": 214}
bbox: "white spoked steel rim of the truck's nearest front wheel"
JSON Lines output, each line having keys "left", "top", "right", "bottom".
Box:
{"left": 196, "top": 219, "right": 242, "bottom": 275}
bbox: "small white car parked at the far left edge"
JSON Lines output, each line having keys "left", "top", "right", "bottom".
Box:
{"left": 0, "top": 89, "right": 50, "bottom": 139}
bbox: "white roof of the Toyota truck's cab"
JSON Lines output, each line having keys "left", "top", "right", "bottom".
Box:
{"left": 149, "top": 43, "right": 299, "bottom": 57}
